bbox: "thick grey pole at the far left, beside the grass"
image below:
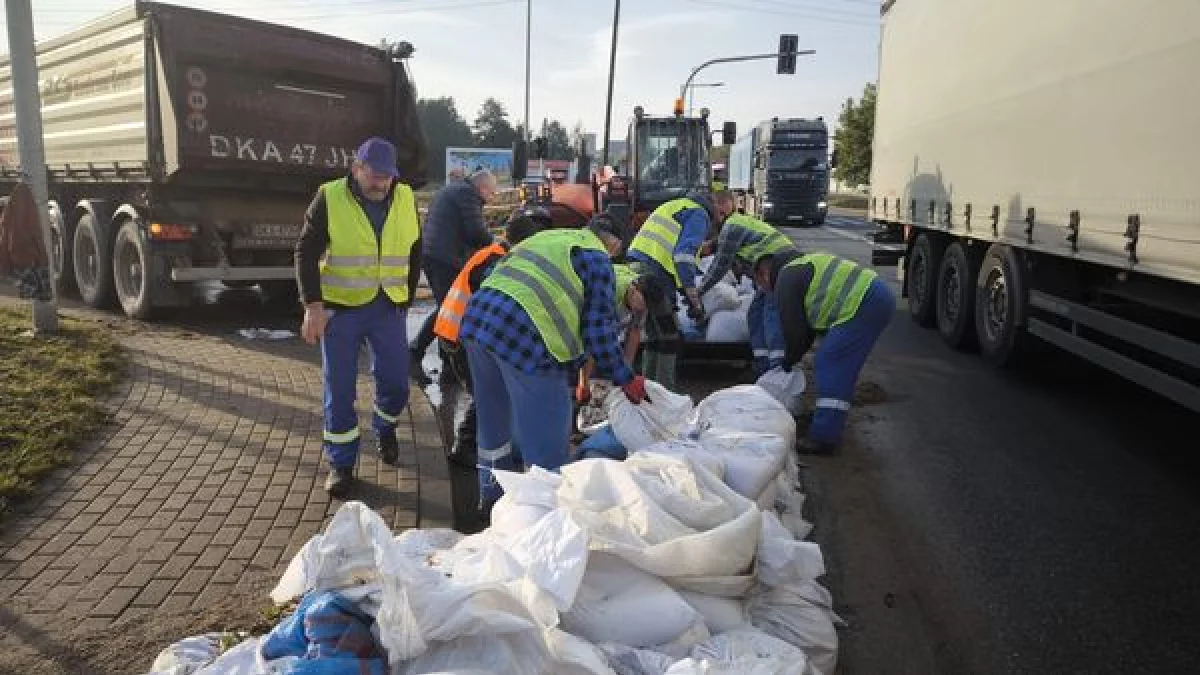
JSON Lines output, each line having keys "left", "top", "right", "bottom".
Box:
{"left": 5, "top": 0, "right": 57, "bottom": 335}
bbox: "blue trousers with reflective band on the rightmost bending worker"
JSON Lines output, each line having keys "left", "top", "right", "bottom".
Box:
{"left": 808, "top": 279, "right": 896, "bottom": 444}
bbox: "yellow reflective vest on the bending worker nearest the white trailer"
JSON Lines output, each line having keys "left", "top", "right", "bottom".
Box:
{"left": 785, "top": 253, "right": 878, "bottom": 331}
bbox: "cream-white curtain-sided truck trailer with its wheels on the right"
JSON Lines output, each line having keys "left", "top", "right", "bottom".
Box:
{"left": 870, "top": 0, "right": 1200, "bottom": 410}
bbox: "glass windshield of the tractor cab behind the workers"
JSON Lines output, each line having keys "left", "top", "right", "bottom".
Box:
{"left": 637, "top": 123, "right": 707, "bottom": 193}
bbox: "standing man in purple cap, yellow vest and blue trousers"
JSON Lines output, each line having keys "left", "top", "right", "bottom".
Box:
{"left": 295, "top": 138, "right": 421, "bottom": 497}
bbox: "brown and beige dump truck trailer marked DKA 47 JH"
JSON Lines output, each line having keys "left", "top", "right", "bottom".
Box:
{"left": 0, "top": 2, "right": 426, "bottom": 318}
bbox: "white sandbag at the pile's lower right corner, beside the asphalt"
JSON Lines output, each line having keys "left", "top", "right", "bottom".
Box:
{"left": 746, "top": 581, "right": 838, "bottom": 675}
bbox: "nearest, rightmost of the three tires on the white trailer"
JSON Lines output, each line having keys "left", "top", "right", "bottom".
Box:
{"left": 974, "top": 244, "right": 1028, "bottom": 366}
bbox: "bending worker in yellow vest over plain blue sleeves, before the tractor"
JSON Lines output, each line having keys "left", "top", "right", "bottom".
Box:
{"left": 628, "top": 196, "right": 733, "bottom": 389}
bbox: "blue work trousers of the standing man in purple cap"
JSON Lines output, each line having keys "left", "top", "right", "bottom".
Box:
{"left": 320, "top": 293, "right": 408, "bottom": 467}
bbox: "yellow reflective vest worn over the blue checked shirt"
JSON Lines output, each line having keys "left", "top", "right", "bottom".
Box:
{"left": 480, "top": 229, "right": 607, "bottom": 363}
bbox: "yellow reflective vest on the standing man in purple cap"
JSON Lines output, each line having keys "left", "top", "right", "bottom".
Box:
{"left": 320, "top": 178, "right": 421, "bottom": 307}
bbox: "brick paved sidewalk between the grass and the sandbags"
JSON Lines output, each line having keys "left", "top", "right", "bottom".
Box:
{"left": 0, "top": 306, "right": 451, "bottom": 653}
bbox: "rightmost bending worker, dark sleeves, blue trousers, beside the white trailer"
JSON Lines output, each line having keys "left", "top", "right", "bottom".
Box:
{"left": 755, "top": 248, "right": 896, "bottom": 454}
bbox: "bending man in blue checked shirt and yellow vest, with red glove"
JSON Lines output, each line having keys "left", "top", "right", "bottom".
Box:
{"left": 461, "top": 217, "right": 646, "bottom": 514}
